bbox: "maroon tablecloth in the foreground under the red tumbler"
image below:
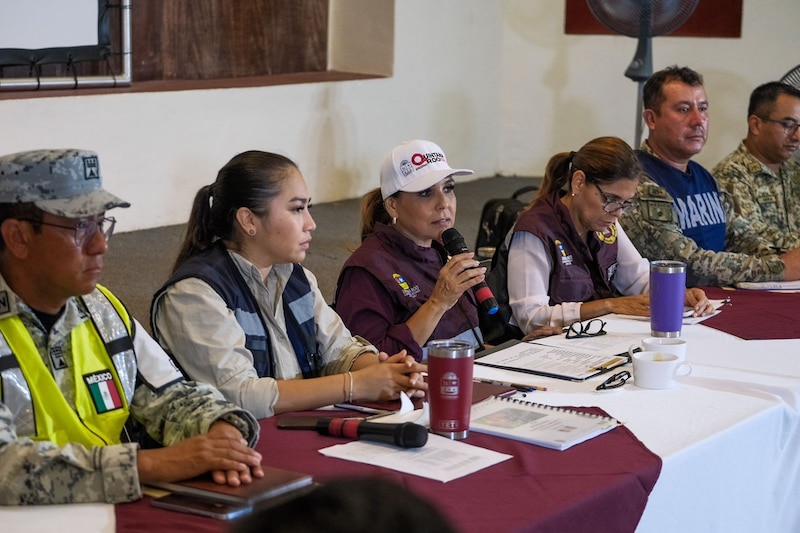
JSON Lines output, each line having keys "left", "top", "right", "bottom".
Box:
{"left": 116, "top": 408, "right": 661, "bottom": 533}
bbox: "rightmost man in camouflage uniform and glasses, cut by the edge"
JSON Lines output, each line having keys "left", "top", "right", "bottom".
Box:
{"left": 712, "top": 81, "right": 800, "bottom": 250}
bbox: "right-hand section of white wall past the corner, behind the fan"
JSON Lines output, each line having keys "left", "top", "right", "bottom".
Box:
{"left": 498, "top": 0, "right": 800, "bottom": 175}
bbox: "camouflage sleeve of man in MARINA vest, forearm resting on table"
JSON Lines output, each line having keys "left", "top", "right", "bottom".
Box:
{"left": 620, "top": 177, "right": 784, "bottom": 287}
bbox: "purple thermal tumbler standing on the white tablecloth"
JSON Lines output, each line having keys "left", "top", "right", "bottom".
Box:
{"left": 650, "top": 261, "right": 686, "bottom": 337}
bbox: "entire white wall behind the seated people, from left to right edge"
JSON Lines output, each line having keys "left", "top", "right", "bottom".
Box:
{"left": 0, "top": 0, "right": 800, "bottom": 231}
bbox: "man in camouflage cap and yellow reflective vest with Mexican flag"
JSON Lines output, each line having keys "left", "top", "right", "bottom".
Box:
{"left": 0, "top": 150, "right": 263, "bottom": 505}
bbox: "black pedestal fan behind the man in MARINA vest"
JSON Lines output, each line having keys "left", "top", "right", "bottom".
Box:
{"left": 586, "top": 0, "right": 700, "bottom": 148}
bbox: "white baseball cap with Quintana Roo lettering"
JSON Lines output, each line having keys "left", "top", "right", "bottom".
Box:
{"left": 381, "top": 139, "right": 474, "bottom": 200}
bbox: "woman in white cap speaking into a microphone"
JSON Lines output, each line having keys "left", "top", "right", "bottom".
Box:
{"left": 334, "top": 140, "right": 486, "bottom": 359}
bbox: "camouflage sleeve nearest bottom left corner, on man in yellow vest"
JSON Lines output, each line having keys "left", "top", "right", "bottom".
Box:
{"left": 0, "top": 403, "right": 142, "bottom": 505}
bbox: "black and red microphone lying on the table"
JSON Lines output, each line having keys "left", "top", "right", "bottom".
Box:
{"left": 316, "top": 418, "right": 428, "bottom": 448}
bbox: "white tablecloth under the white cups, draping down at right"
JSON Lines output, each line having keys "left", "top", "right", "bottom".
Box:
{"left": 475, "top": 317, "right": 800, "bottom": 533}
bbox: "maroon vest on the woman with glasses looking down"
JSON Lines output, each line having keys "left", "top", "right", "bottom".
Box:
{"left": 514, "top": 191, "right": 620, "bottom": 305}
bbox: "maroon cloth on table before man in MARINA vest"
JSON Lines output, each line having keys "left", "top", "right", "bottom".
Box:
{"left": 703, "top": 287, "right": 800, "bottom": 341}
